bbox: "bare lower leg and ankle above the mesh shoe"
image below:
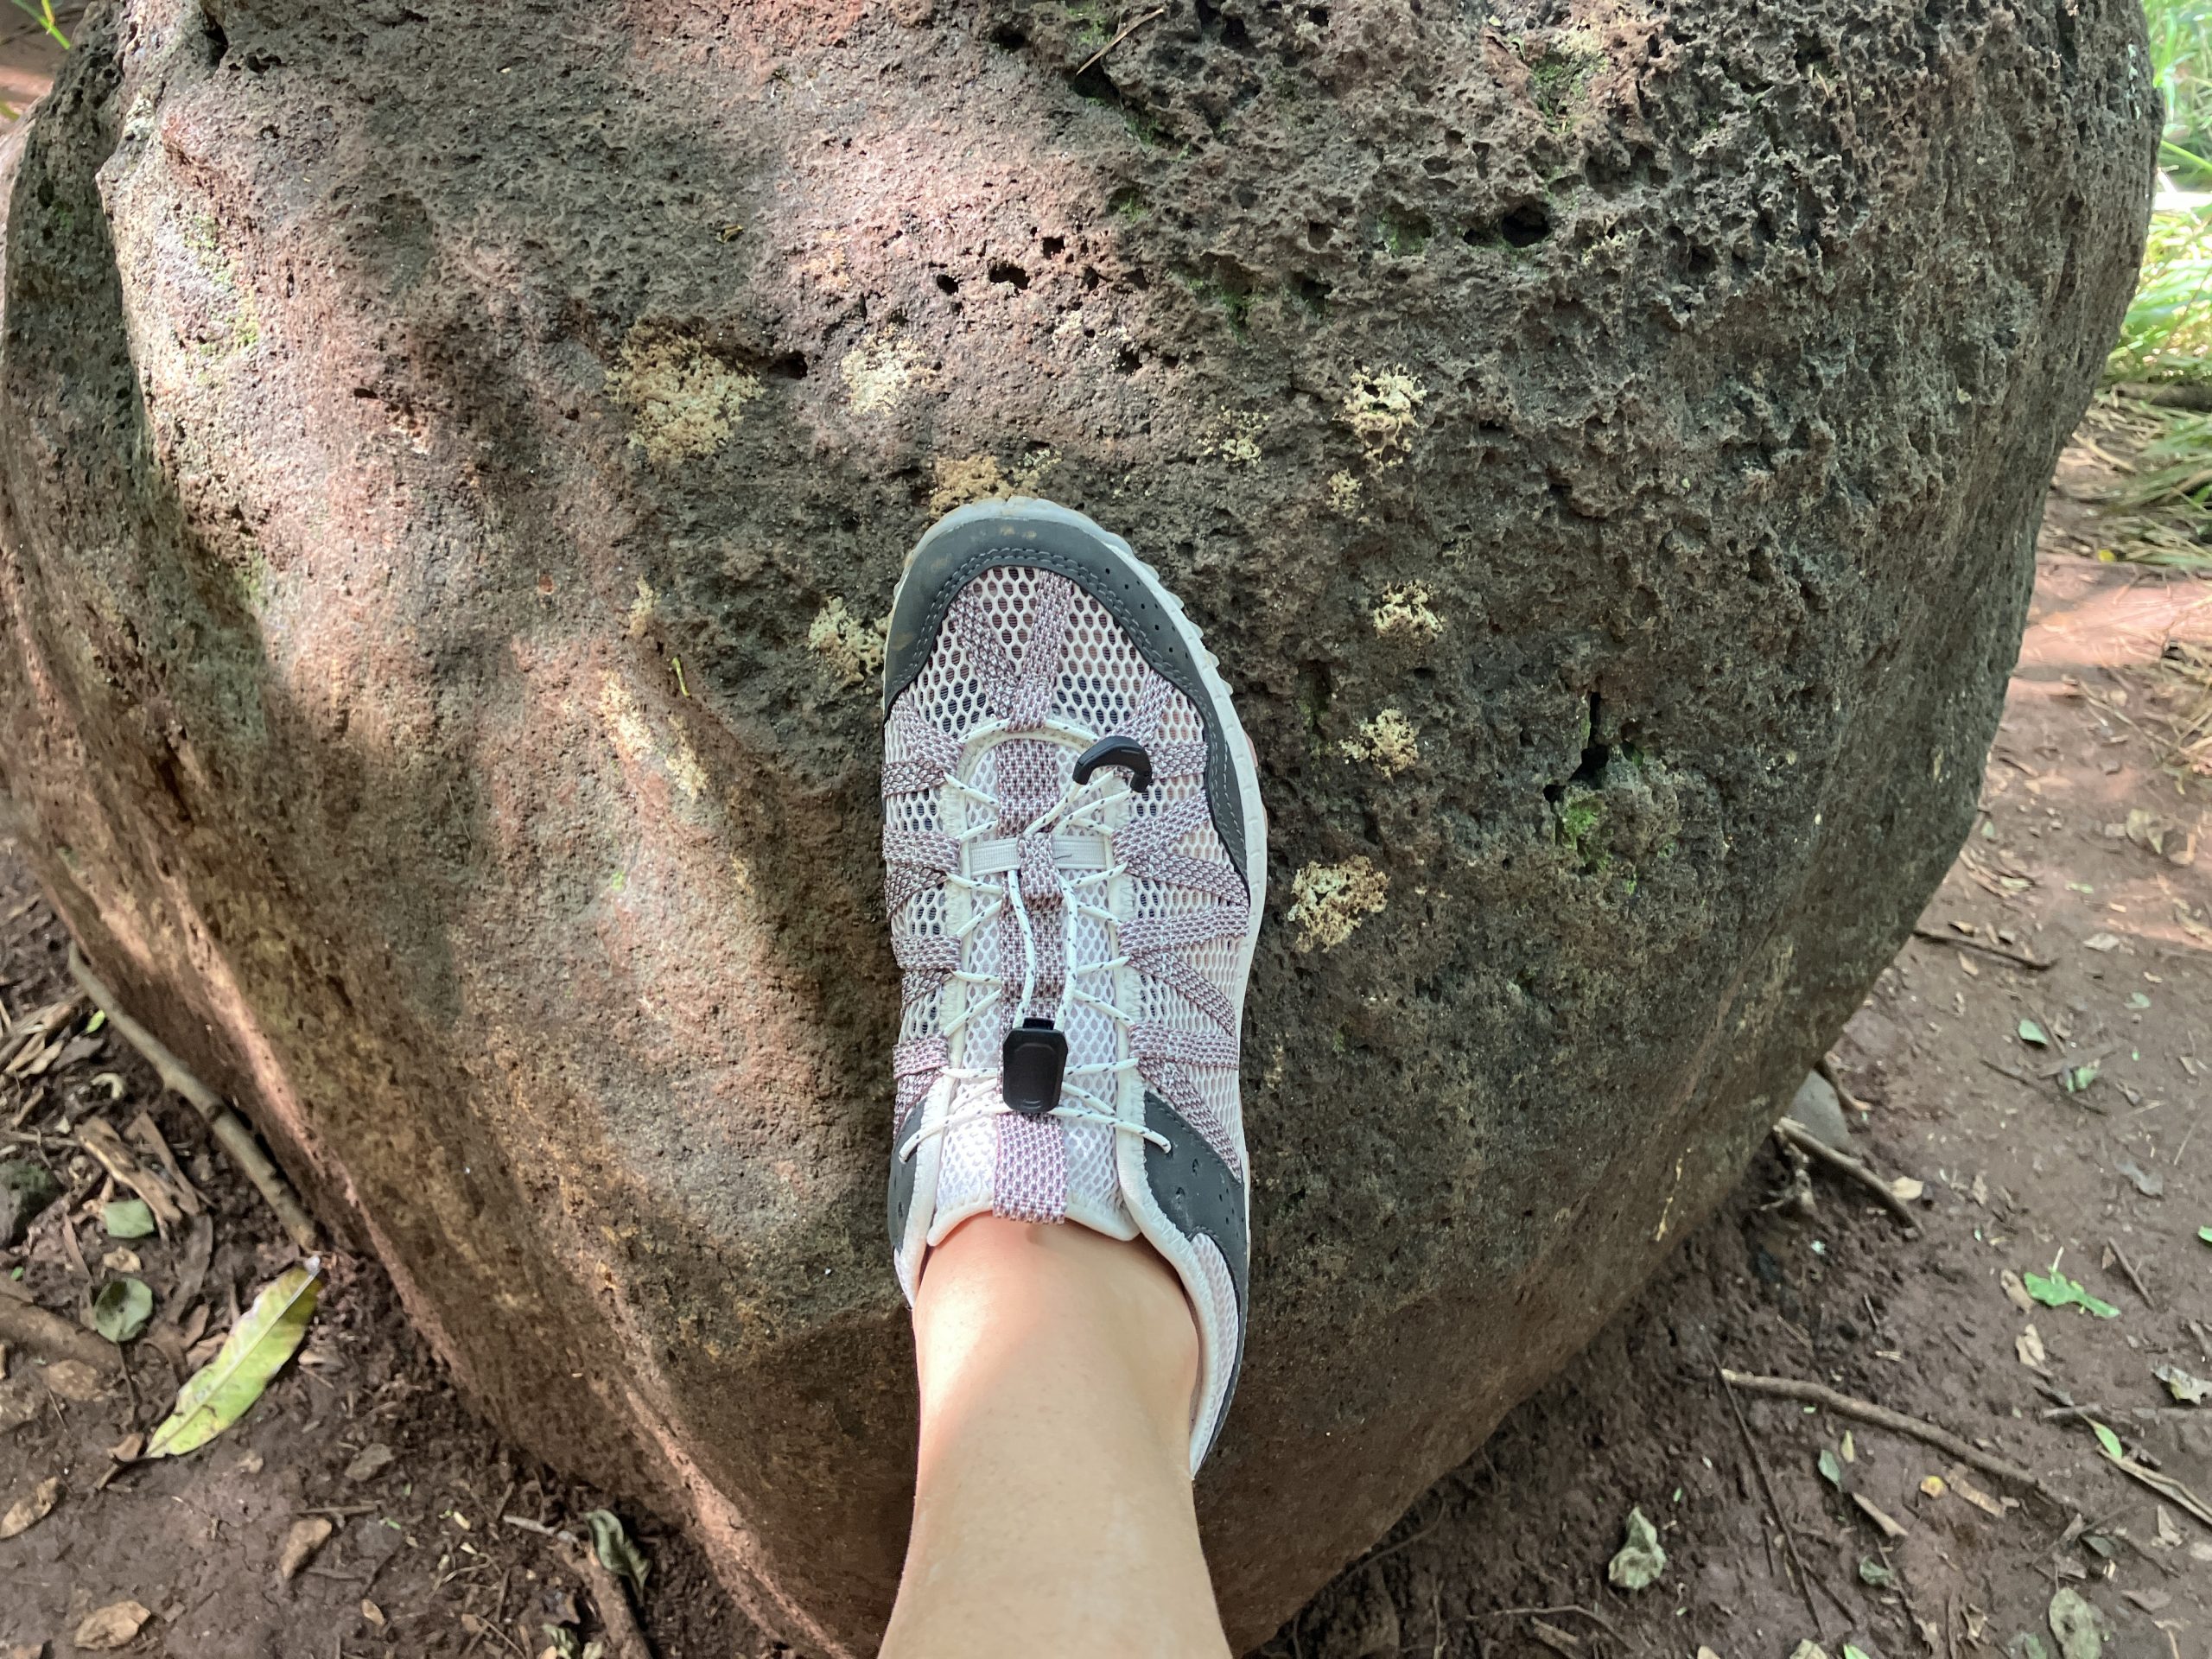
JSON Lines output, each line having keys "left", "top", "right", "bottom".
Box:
{"left": 882, "top": 1217, "right": 1228, "bottom": 1659}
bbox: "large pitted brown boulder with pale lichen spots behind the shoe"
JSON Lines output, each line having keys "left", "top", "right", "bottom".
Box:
{"left": 0, "top": 0, "right": 2159, "bottom": 1652}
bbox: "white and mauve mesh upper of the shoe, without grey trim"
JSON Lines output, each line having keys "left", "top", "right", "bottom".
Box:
{"left": 885, "top": 566, "right": 1249, "bottom": 1221}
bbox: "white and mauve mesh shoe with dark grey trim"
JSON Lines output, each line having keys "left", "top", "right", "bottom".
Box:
{"left": 882, "top": 500, "right": 1268, "bottom": 1469}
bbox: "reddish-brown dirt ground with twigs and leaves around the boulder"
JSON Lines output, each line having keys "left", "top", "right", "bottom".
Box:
{"left": 0, "top": 188, "right": 2212, "bottom": 1659}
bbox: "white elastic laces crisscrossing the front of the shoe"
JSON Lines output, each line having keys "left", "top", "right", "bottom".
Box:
{"left": 898, "top": 770, "right": 1174, "bottom": 1161}
